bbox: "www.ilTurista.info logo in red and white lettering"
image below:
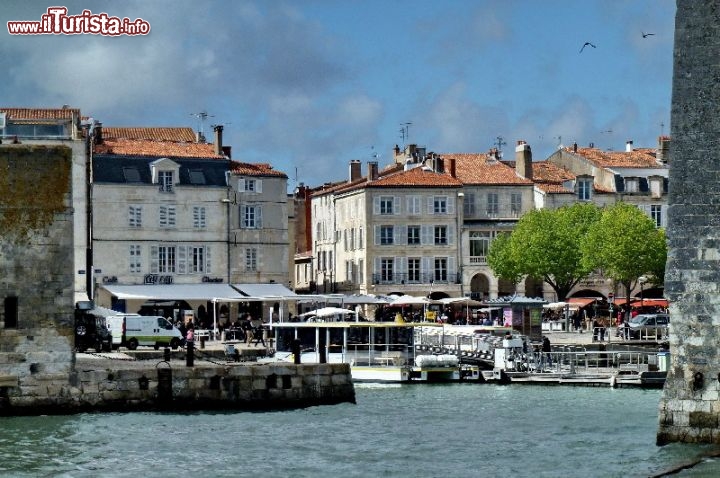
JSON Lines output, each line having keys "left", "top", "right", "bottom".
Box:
{"left": 8, "top": 7, "right": 150, "bottom": 36}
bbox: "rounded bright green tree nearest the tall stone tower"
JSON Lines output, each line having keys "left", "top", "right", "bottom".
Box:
{"left": 582, "top": 202, "right": 667, "bottom": 318}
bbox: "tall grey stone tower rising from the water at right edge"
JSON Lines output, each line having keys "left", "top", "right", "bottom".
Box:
{"left": 657, "top": 0, "right": 720, "bottom": 445}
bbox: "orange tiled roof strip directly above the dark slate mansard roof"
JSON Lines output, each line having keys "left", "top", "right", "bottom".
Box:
{"left": 94, "top": 139, "right": 225, "bottom": 159}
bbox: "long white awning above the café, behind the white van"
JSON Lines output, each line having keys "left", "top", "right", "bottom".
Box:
{"left": 100, "top": 283, "right": 250, "bottom": 302}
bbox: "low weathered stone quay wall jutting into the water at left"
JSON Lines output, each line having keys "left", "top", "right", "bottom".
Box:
{"left": 0, "top": 359, "right": 355, "bottom": 416}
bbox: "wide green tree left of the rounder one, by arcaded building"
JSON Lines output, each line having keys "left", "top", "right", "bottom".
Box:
{"left": 488, "top": 203, "right": 600, "bottom": 300}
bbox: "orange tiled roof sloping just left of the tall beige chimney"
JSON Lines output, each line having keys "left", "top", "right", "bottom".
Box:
{"left": 440, "top": 153, "right": 532, "bottom": 185}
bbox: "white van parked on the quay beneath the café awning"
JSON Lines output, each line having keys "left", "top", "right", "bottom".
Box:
{"left": 105, "top": 314, "right": 183, "bottom": 350}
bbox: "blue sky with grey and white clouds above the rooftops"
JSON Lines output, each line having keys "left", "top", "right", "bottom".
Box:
{"left": 0, "top": 0, "right": 675, "bottom": 190}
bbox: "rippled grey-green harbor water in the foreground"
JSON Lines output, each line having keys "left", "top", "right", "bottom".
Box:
{"left": 0, "top": 384, "right": 720, "bottom": 478}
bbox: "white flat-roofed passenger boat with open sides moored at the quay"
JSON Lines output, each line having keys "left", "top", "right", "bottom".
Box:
{"left": 271, "top": 321, "right": 461, "bottom": 382}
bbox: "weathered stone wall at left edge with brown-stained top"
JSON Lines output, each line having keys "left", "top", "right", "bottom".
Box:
{"left": 0, "top": 144, "right": 74, "bottom": 408}
